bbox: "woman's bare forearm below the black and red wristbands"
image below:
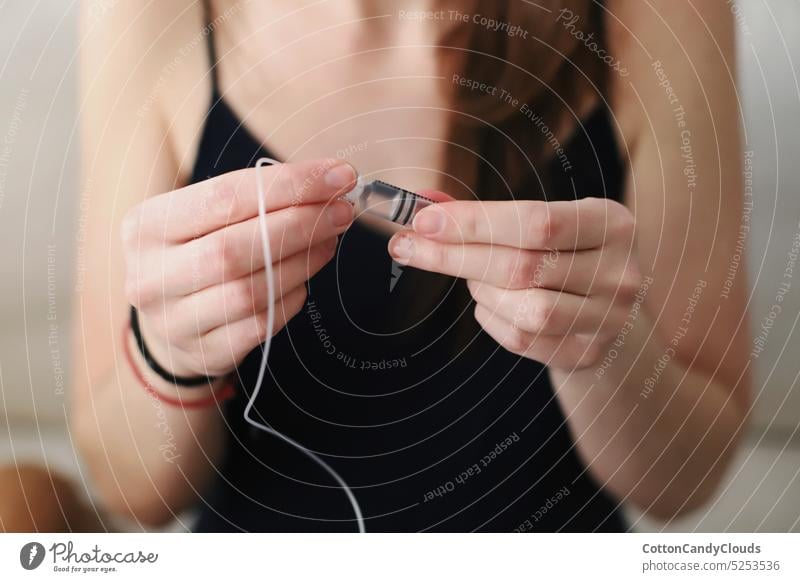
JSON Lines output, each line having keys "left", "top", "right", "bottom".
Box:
{"left": 72, "top": 328, "right": 224, "bottom": 525}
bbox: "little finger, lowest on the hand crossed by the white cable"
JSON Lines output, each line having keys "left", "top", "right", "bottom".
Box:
{"left": 200, "top": 285, "right": 308, "bottom": 372}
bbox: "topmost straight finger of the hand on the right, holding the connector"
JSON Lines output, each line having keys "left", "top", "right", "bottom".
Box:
{"left": 413, "top": 198, "right": 630, "bottom": 250}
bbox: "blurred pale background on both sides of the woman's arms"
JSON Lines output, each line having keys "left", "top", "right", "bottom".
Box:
{"left": 0, "top": 0, "right": 800, "bottom": 532}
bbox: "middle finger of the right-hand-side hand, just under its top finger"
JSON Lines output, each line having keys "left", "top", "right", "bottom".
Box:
{"left": 389, "top": 231, "right": 608, "bottom": 295}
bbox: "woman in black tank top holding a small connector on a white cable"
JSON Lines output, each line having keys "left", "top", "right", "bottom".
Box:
{"left": 73, "top": 0, "right": 749, "bottom": 531}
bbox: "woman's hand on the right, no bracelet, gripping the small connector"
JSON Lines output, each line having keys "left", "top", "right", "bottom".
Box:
{"left": 389, "top": 198, "right": 640, "bottom": 370}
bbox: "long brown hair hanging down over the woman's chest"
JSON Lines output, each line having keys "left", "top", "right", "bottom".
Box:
{"left": 440, "top": 0, "right": 608, "bottom": 199}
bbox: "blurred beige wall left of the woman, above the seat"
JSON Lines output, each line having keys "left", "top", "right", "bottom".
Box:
{"left": 0, "top": 0, "right": 78, "bottom": 422}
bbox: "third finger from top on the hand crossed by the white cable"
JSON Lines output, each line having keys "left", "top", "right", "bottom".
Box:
{"left": 166, "top": 238, "right": 336, "bottom": 341}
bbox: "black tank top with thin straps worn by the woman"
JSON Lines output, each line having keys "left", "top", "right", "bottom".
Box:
{"left": 192, "top": 4, "right": 625, "bottom": 532}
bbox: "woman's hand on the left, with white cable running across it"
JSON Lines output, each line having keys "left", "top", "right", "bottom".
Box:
{"left": 122, "top": 160, "right": 356, "bottom": 376}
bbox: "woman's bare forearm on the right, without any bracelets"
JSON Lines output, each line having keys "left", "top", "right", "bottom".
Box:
{"left": 551, "top": 311, "right": 746, "bottom": 517}
